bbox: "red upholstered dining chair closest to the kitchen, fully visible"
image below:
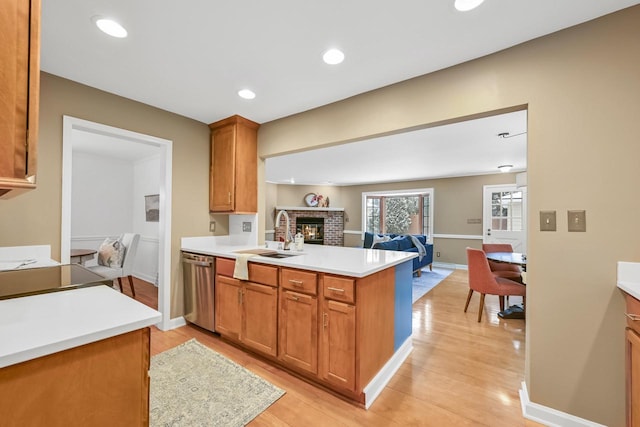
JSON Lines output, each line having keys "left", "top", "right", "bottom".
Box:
{"left": 464, "top": 248, "right": 527, "bottom": 322}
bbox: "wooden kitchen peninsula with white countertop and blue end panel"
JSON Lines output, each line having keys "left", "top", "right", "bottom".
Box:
{"left": 182, "top": 237, "right": 418, "bottom": 408}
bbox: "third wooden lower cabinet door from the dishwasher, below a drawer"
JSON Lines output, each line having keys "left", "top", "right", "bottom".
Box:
{"left": 280, "top": 291, "right": 318, "bottom": 374}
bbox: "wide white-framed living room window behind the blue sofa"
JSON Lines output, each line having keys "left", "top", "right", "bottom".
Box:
{"left": 362, "top": 188, "right": 433, "bottom": 241}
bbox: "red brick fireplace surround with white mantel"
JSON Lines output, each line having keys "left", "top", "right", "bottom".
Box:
{"left": 273, "top": 206, "right": 344, "bottom": 246}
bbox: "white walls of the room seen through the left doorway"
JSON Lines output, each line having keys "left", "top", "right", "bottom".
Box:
{"left": 71, "top": 151, "right": 160, "bottom": 284}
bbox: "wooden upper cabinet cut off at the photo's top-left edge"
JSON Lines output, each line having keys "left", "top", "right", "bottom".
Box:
{"left": 0, "top": 0, "right": 40, "bottom": 198}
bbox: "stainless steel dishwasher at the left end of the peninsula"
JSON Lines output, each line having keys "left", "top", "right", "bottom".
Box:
{"left": 182, "top": 252, "right": 216, "bottom": 332}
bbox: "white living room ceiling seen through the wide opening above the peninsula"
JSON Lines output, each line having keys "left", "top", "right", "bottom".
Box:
{"left": 266, "top": 111, "right": 527, "bottom": 185}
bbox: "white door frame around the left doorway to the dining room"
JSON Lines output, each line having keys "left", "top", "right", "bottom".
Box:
{"left": 60, "top": 116, "right": 173, "bottom": 330}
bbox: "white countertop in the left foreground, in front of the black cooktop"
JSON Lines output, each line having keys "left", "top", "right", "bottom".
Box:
{"left": 0, "top": 286, "right": 162, "bottom": 368}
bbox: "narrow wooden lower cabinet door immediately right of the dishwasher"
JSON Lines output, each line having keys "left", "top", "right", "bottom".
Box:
{"left": 215, "top": 275, "right": 242, "bottom": 340}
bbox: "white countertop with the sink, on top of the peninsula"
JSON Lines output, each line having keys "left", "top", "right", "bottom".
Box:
{"left": 181, "top": 237, "right": 418, "bottom": 277}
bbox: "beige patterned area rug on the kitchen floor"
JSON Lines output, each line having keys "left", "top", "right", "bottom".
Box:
{"left": 149, "top": 339, "right": 285, "bottom": 427}
